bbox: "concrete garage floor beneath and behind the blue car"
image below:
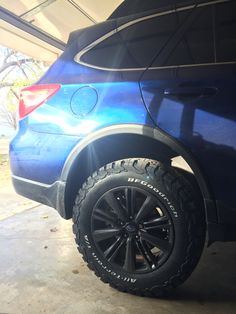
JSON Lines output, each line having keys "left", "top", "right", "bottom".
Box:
{"left": 0, "top": 187, "right": 236, "bottom": 314}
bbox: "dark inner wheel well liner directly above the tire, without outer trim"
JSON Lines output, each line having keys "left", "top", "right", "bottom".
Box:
{"left": 65, "top": 134, "right": 205, "bottom": 218}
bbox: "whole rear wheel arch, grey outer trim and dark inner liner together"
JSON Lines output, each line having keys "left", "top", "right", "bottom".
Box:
{"left": 61, "top": 124, "right": 216, "bottom": 223}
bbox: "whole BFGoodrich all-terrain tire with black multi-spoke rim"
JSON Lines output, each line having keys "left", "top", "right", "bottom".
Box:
{"left": 73, "top": 158, "right": 206, "bottom": 296}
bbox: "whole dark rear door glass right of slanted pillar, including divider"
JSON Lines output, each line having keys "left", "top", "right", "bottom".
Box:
{"left": 152, "top": 1, "right": 236, "bottom": 67}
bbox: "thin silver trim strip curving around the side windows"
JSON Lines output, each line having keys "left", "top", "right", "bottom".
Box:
{"left": 74, "top": 0, "right": 230, "bottom": 72}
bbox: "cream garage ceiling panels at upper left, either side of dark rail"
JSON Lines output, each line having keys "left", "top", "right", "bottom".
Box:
{"left": 0, "top": 0, "right": 123, "bottom": 62}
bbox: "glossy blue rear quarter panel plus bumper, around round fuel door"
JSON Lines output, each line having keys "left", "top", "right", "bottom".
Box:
{"left": 10, "top": 82, "right": 153, "bottom": 184}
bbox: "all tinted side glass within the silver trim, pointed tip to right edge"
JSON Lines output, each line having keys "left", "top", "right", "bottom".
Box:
{"left": 80, "top": 0, "right": 236, "bottom": 69}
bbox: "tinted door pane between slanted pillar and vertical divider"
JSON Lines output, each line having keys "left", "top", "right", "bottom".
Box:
{"left": 162, "top": 7, "right": 214, "bottom": 66}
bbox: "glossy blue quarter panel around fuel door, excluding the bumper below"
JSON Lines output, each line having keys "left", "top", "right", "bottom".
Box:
{"left": 27, "top": 82, "right": 151, "bottom": 138}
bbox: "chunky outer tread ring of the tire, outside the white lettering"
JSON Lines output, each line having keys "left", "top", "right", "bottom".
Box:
{"left": 72, "top": 158, "right": 205, "bottom": 297}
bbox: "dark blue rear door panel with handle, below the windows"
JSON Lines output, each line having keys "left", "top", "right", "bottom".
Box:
{"left": 140, "top": 64, "right": 236, "bottom": 208}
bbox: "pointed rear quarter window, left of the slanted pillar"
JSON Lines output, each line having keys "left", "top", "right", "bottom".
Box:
{"left": 81, "top": 12, "right": 188, "bottom": 69}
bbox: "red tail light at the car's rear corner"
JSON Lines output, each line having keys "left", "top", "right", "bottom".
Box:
{"left": 19, "top": 84, "right": 61, "bottom": 119}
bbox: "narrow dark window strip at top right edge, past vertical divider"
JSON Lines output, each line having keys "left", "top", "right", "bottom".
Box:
{"left": 216, "top": 1, "right": 236, "bottom": 62}
